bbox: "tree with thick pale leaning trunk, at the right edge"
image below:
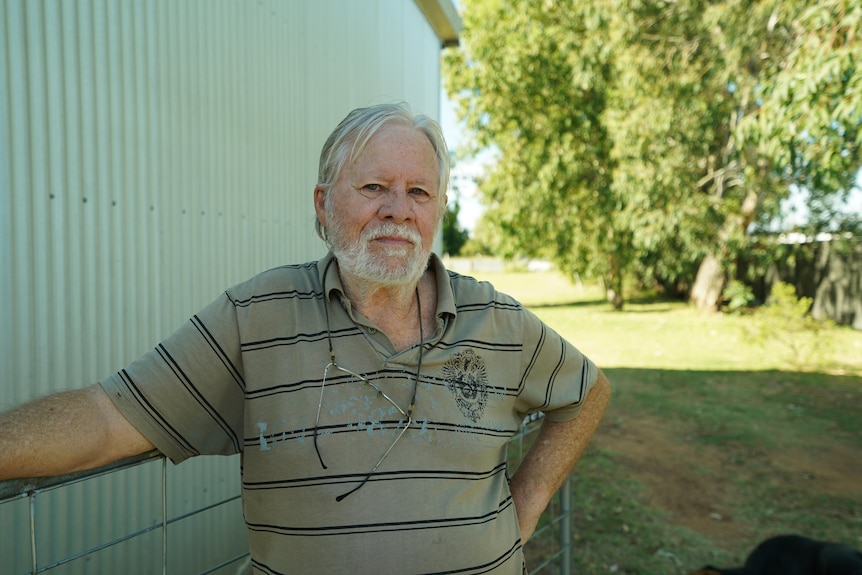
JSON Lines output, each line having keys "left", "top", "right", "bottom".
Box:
{"left": 691, "top": 0, "right": 862, "bottom": 308}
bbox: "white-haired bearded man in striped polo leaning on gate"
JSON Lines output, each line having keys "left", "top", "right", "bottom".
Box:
{"left": 0, "top": 104, "right": 609, "bottom": 574}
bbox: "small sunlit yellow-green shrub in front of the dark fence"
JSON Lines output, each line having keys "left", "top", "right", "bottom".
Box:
{"left": 747, "top": 282, "right": 834, "bottom": 365}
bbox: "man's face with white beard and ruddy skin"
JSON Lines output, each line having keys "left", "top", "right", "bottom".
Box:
{"left": 314, "top": 124, "right": 445, "bottom": 285}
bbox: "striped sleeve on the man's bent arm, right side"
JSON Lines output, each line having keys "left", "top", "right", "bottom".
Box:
{"left": 517, "top": 309, "right": 598, "bottom": 421}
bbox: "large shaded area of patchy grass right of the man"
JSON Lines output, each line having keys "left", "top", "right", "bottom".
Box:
{"left": 573, "top": 368, "right": 862, "bottom": 575}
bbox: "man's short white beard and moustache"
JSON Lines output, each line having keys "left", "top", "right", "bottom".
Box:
{"left": 326, "top": 212, "right": 431, "bottom": 285}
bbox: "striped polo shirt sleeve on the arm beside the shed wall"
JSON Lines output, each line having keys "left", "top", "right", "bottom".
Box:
{"left": 100, "top": 294, "right": 244, "bottom": 463}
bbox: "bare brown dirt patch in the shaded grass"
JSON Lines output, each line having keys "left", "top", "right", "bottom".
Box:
{"left": 593, "top": 416, "right": 862, "bottom": 547}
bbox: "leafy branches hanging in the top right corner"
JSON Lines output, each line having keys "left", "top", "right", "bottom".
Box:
{"left": 739, "top": 0, "right": 862, "bottom": 198}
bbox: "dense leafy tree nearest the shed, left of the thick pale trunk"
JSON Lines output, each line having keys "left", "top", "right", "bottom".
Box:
{"left": 446, "top": 0, "right": 729, "bottom": 307}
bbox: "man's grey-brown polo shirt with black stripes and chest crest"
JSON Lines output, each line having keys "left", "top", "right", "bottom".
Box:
{"left": 101, "top": 254, "right": 597, "bottom": 574}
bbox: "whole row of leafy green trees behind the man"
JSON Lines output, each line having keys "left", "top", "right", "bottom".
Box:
{"left": 444, "top": 0, "right": 862, "bottom": 309}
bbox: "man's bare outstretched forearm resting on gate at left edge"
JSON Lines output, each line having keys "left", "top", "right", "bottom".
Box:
{"left": 0, "top": 384, "right": 153, "bottom": 480}
